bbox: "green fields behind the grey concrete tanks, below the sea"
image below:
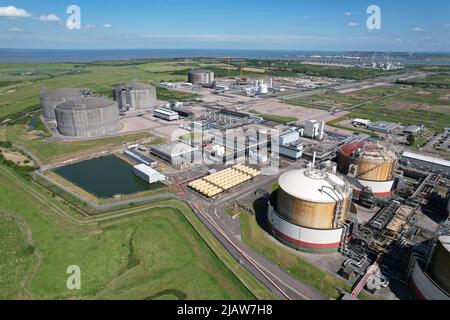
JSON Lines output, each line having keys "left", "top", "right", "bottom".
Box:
{"left": 0, "top": 60, "right": 229, "bottom": 119}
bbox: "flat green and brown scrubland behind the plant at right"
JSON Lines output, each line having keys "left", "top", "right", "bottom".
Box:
{"left": 289, "top": 82, "right": 450, "bottom": 133}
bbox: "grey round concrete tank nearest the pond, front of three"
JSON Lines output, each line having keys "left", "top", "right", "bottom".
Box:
{"left": 55, "top": 96, "right": 120, "bottom": 138}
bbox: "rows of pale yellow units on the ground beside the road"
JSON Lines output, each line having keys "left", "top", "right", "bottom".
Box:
{"left": 189, "top": 165, "right": 261, "bottom": 198}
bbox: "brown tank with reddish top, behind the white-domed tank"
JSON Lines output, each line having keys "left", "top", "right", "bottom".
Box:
{"left": 338, "top": 142, "right": 397, "bottom": 197}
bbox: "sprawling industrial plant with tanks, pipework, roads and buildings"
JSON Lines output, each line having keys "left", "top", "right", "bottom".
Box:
{"left": 29, "top": 63, "right": 450, "bottom": 300}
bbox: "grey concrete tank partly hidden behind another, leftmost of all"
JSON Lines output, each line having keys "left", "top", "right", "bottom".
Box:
{"left": 40, "top": 88, "right": 88, "bottom": 120}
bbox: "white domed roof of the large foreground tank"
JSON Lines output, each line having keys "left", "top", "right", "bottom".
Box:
{"left": 279, "top": 169, "right": 351, "bottom": 203}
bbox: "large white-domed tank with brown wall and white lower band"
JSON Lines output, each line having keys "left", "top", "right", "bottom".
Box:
{"left": 268, "top": 169, "right": 352, "bottom": 252}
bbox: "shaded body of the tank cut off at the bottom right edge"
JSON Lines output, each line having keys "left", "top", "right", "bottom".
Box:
{"left": 431, "top": 235, "right": 450, "bottom": 294}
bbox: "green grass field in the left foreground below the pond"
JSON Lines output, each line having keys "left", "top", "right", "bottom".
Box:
{"left": 0, "top": 166, "right": 253, "bottom": 300}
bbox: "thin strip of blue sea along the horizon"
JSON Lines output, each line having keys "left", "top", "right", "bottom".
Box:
{"left": 0, "top": 48, "right": 450, "bottom": 66}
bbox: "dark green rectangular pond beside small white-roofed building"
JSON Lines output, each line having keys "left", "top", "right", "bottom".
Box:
{"left": 54, "top": 155, "right": 164, "bottom": 198}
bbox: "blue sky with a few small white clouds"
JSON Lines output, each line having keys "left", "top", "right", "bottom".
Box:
{"left": 0, "top": 0, "right": 450, "bottom": 52}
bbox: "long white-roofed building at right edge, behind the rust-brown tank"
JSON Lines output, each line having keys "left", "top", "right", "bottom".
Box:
{"left": 400, "top": 152, "right": 450, "bottom": 177}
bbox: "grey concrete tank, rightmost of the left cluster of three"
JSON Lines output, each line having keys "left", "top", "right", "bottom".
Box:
{"left": 113, "top": 83, "right": 156, "bottom": 111}
